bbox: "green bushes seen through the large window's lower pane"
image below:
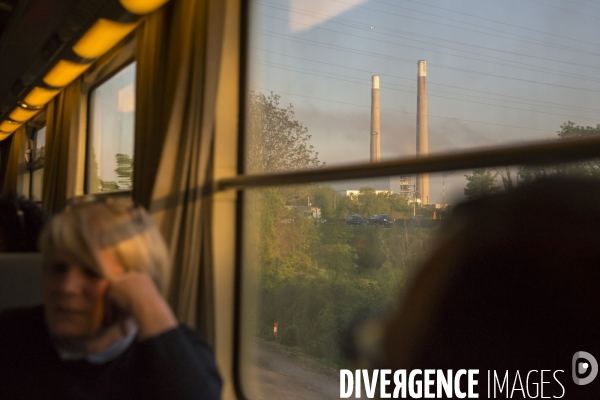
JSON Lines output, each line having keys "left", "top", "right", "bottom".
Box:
{"left": 256, "top": 189, "right": 433, "bottom": 365}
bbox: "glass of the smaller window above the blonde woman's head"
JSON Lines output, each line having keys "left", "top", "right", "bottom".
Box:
{"left": 87, "top": 63, "right": 135, "bottom": 193}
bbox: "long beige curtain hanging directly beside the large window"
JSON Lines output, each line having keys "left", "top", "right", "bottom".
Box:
{"left": 134, "top": 0, "right": 225, "bottom": 344}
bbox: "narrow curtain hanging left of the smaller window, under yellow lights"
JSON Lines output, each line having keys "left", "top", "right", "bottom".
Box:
{"left": 42, "top": 78, "right": 81, "bottom": 214}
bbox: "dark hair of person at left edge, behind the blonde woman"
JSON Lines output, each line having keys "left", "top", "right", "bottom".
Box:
{"left": 0, "top": 193, "right": 47, "bottom": 252}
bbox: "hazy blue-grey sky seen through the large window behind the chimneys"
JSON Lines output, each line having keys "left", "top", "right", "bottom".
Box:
{"left": 248, "top": 0, "right": 600, "bottom": 203}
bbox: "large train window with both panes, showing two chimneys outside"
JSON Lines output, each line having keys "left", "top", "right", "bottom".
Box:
{"left": 241, "top": 0, "right": 600, "bottom": 398}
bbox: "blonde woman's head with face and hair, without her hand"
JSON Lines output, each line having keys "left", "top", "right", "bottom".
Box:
{"left": 40, "top": 199, "right": 169, "bottom": 338}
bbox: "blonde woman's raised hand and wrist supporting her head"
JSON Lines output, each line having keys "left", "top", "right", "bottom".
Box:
{"left": 100, "top": 250, "right": 177, "bottom": 340}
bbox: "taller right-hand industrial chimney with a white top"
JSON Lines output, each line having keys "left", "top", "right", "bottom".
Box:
{"left": 416, "top": 60, "right": 430, "bottom": 204}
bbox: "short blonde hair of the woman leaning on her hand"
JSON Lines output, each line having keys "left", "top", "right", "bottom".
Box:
{"left": 40, "top": 198, "right": 170, "bottom": 294}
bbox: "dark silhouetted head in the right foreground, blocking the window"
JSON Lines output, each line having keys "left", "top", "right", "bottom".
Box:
{"left": 385, "top": 178, "right": 600, "bottom": 397}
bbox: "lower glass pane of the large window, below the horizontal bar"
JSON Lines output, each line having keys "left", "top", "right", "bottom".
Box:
{"left": 241, "top": 159, "right": 600, "bottom": 399}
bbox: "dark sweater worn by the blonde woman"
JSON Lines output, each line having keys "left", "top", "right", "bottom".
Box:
{"left": 0, "top": 307, "right": 221, "bottom": 399}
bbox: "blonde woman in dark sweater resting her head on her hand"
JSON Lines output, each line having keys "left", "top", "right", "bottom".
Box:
{"left": 0, "top": 200, "right": 221, "bottom": 399}
